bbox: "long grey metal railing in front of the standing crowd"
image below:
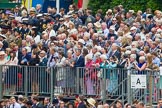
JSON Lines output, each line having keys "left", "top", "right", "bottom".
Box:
{"left": 0, "top": 65, "right": 159, "bottom": 103}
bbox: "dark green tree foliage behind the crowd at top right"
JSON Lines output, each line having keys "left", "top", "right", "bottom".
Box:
{"left": 88, "top": 0, "right": 162, "bottom": 13}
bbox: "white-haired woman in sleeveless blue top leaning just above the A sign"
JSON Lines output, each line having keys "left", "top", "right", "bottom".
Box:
{"left": 133, "top": 56, "right": 146, "bottom": 74}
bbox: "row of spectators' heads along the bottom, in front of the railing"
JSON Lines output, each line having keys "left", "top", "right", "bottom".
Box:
{"left": 0, "top": 95, "right": 162, "bottom": 108}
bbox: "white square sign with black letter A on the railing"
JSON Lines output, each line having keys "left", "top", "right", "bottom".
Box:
{"left": 131, "top": 75, "right": 146, "bottom": 89}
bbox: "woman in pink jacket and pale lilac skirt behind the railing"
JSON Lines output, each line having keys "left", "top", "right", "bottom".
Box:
{"left": 85, "top": 54, "right": 95, "bottom": 95}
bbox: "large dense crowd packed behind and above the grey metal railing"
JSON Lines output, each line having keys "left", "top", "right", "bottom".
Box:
{"left": 0, "top": 2, "right": 162, "bottom": 107}
